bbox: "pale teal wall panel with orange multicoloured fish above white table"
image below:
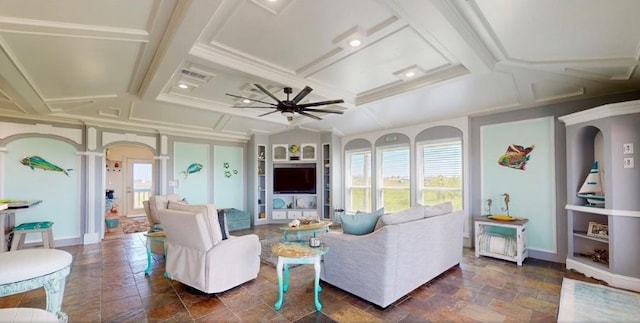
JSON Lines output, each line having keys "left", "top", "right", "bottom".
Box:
{"left": 480, "top": 117, "right": 557, "bottom": 252}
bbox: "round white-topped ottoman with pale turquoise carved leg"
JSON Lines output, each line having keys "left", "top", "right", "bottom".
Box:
{"left": 0, "top": 249, "right": 73, "bottom": 322}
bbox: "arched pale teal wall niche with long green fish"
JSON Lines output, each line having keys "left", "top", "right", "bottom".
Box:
{"left": 2, "top": 138, "right": 82, "bottom": 241}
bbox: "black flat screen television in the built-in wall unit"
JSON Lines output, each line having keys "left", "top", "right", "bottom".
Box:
{"left": 273, "top": 167, "right": 316, "bottom": 194}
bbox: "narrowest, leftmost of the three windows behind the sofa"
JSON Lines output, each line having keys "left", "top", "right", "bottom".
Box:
{"left": 346, "top": 150, "right": 371, "bottom": 212}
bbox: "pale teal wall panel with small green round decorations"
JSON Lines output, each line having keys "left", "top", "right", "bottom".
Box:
{"left": 213, "top": 146, "right": 246, "bottom": 211}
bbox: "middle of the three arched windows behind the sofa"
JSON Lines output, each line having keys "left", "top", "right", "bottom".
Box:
{"left": 378, "top": 146, "right": 411, "bottom": 213}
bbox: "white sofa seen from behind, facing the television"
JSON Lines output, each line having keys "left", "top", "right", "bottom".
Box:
{"left": 320, "top": 204, "right": 464, "bottom": 307}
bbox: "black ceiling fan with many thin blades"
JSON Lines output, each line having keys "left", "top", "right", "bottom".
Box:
{"left": 226, "top": 83, "right": 344, "bottom": 121}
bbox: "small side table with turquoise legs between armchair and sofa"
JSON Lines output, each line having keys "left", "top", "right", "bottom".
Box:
{"left": 271, "top": 242, "right": 329, "bottom": 311}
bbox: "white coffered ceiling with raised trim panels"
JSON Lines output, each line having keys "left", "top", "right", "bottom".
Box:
{"left": 0, "top": 0, "right": 640, "bottom": 141}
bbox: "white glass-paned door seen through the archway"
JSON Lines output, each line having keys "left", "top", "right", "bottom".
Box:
{"left": 126, "top": 159, "right": 153, "bottom": 216}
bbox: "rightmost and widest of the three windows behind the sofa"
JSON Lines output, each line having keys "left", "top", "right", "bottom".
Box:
{"left": 418, "top": 138, "right": 462, "bottom": 210}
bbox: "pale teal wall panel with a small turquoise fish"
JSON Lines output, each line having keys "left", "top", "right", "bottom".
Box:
{"left": 173, "top": 142, "right": 211, "bottom": 204}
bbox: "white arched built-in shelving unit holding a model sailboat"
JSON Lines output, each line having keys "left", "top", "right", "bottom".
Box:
{"left": 559, "top": 101, "right": 640, "bottom": 291}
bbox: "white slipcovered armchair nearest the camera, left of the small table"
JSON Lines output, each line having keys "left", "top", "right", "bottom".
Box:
{"left": 158, "top": 203, "right": 261, "bottom": 293}
